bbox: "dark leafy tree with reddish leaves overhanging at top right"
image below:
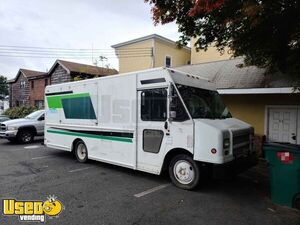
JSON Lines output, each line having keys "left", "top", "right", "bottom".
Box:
{"left": 145, "top": 0, "right": 300, "bottom": 81}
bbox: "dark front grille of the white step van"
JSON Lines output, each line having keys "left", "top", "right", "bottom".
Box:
{"left": 233, "top": 130, "right": 250, "bottom": 156}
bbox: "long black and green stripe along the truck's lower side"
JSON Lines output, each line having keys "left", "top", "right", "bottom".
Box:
{"left": 47, "top": 129, "right": 132, "bottom": 143}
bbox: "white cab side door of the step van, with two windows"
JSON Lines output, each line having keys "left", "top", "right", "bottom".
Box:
{"left": 137, "top": 88, "right": 169, "bottom": 174}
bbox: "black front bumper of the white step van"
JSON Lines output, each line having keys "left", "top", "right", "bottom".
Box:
{"left": 213, "top": 152, "right": 258, "bottom": 178}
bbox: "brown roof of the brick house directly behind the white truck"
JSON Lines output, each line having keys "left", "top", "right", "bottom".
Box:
{"left": 48, "top": 59, "right": 118, "bottom": 76}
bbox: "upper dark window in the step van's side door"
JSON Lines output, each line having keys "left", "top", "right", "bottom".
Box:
{"left": 141, "top": 89, "right": 167, "bottom": 121}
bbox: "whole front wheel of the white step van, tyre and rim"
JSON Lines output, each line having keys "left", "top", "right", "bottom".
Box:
{"left": 169, "top": 154, "right": 200, "bottom": 190}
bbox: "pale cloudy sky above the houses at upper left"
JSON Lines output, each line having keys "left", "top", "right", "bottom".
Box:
{"left": 0, "top": 0, "right": 179, "bottom": 79}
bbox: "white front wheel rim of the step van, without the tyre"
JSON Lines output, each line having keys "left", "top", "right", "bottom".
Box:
{"left": 173, "top": 160, "right": 195, "bottom": 184}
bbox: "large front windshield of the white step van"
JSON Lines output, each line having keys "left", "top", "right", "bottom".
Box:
{"left": 176, "top": 84, "right": 231, "bottom": 119}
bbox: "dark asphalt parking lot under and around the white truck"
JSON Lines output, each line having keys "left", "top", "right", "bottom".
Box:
{"left": 0, "top": 139, "right": 300, "bottom": 225}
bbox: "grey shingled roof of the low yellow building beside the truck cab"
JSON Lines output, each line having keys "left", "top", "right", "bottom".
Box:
{"left": 175, "top": 58, "right": 294, "bottom": 89}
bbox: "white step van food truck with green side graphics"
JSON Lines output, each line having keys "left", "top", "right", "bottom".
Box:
{"left": 44, "top": 68, "right": 255, "bottom": 189}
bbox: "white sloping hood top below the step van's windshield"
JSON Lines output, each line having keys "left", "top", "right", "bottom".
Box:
{"left": 194, "top": 118, "right": 252, "bottom": 131}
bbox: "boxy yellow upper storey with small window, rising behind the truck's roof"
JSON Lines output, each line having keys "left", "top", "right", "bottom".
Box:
{"left": 111, "top": 34, "right": 191, "bottom": 73}
